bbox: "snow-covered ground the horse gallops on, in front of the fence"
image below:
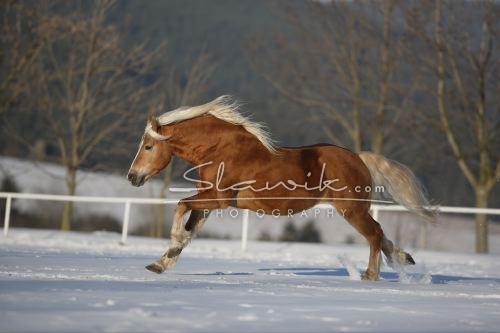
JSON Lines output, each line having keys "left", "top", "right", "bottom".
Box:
{"left": 0, "top": 229, "right": 500, "bottom": 332}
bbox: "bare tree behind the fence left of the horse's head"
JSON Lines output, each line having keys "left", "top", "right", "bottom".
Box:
{"left": 31, "top": 1, "right": 162, "bottom": 230}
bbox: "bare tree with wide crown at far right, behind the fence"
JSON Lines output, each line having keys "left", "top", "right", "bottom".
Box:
{"left": 407, "top": 1, "right": 500, "bottom": 253}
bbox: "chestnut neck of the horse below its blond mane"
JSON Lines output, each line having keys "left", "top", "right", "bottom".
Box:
{"left": 167, "top": 116, "right": 261, "bottom": 165}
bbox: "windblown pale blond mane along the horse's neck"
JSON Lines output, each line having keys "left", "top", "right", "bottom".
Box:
{"left": 158, "top": 95, "right": 276, "bottom": 153}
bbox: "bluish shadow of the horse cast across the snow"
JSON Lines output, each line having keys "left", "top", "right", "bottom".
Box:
{"left": 259, "top": 267, "right": 500, "bottom": 284}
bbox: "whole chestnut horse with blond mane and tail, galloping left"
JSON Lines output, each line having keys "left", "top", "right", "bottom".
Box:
{"left": 127, "top": 96, "right": 434, "bottom": 280}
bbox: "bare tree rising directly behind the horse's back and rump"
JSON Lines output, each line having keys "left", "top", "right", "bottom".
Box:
{"left": 248, "top": 0, "right": 411, "bottom": 153}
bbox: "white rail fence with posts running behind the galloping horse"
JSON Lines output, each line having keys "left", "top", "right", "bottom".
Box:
{"left": 0, "top": 189, "right": 500, "bottom": 251}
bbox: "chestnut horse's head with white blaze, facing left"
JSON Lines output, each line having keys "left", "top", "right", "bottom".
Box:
{"left": 127, "top": 116, "right": 172, "bottom": 186}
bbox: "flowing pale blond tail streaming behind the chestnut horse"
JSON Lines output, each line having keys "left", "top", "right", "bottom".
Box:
{"left": 358, "top": 151, "right": 436, "bottom": 222}
